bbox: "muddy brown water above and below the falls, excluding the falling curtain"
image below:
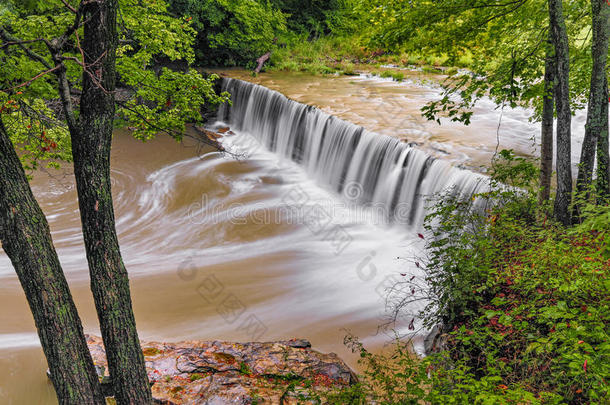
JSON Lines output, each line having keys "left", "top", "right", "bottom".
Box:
{"left": 0, "top": 71, "right": 578, "bottom": 404}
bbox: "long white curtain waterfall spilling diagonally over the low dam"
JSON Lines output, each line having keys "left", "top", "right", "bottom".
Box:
{"left": 217, "top": 78, "right": 487, "bottom": 226}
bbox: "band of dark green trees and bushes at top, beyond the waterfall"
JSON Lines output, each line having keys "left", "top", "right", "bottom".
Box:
{"left": 164, "top": 0, "right": 362, "bottom": 67}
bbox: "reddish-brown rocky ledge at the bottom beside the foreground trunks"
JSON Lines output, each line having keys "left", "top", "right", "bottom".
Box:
{"left": 87, "top": 336, "right": 357, "bottom": 405}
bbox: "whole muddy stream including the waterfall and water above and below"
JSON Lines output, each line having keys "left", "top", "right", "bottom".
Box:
{"left": 0, "top": 71, "right": 578, "bottom": 404}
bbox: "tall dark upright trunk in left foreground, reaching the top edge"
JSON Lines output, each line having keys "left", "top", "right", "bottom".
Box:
{"left": 71, "top": 0, "right": 152, "bottom": 405}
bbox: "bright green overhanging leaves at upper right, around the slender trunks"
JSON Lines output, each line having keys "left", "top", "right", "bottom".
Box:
{"left": 362, "top": 0, "right": 591, "bottom": 124}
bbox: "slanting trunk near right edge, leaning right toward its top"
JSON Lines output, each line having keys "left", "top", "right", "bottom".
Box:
{"left": 574, "top": 0, "right": 610, "bottom": 220}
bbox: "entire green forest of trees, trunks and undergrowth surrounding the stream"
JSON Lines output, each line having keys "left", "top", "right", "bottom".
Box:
{"left": 0, "top": 0, "right": 610, "bottom": 405}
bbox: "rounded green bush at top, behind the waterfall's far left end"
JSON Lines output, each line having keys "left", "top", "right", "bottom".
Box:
{"left": 171, "top": 0, "right": 286, "bottom": 66}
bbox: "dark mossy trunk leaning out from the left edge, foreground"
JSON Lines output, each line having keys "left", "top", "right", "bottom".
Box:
{"left": 0, "top": 119, "right": 105, "bottom": 405}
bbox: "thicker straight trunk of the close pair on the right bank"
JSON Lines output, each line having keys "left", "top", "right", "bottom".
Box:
{"left": 549, "top": 0, "right": 572, "bottom": 225}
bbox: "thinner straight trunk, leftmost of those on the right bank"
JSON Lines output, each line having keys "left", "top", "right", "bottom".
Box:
{"left": 538, "top": 35, "right": 556, "bottom": 204}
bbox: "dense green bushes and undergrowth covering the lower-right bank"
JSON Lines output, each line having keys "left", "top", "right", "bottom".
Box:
{"left": 331, "top": 151, "right": 610, "bottom": 405}
